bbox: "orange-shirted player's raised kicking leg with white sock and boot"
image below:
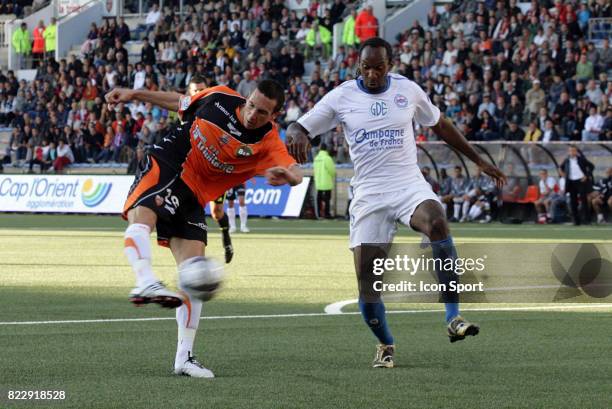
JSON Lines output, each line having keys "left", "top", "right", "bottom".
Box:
{"left": 124, "top": 206, "right": 182, "bottom": 308}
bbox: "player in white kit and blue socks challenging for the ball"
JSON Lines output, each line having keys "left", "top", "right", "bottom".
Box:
{"left": 287, "top": 37, "right": 506, "bottom": 368}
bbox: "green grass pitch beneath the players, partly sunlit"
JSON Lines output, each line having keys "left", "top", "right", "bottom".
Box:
{"left": 0, "top": 215, "right": 612, "bottom": 409}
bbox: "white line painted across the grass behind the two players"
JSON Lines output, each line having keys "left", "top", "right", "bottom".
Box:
{"left": 0, "top": 300, "right": 612, "bottom": 325}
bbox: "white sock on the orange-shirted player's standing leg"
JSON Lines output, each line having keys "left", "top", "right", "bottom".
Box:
{"left": 174, "top": 293, "right": 202, "bottom": 368}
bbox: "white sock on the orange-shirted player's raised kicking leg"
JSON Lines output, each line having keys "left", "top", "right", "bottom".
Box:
{"left": 123, "top": 223, "right": 158, "bottom": 287}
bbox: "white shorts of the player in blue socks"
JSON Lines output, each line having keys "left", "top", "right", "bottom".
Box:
{"left": 349, "top": 179, "right": 441, "bottom": 249}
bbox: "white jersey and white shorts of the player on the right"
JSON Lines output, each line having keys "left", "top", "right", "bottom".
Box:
{"left": 298, "top": 74, "right": 440, "bottom": 248}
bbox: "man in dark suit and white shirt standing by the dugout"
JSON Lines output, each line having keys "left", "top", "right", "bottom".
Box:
{"left": 561, "top": 145, "right": 595, "bottom": 226}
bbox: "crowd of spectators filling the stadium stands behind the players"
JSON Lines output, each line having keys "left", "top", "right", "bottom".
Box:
{"left": 0, "top": 0, "right": 612, "bottom": 222}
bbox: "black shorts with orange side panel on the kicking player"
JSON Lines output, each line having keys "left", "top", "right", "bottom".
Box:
{"left": 123, "top": 155, "right": 208, "bottom": 247}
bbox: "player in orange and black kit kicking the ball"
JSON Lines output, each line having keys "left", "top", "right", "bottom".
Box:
{"left": 106, "top": 80, "right": 302, "bottom": 378}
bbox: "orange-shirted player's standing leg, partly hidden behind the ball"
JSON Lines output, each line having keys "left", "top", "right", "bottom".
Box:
{"left": 170, "top": 237, "right": 215, "bottom": 378}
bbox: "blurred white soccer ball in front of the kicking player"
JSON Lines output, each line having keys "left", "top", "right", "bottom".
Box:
{"left": 179, "top": 257, "right": 225, "bottom": 301}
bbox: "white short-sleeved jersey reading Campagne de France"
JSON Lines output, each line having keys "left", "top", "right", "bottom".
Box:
{"left": 298, "top": 73, "right": 440, "bottom": 194}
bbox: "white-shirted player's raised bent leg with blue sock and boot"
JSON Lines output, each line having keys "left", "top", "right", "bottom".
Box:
{"left": 410, "top": 200, "right": 480, "bottom": 342}
